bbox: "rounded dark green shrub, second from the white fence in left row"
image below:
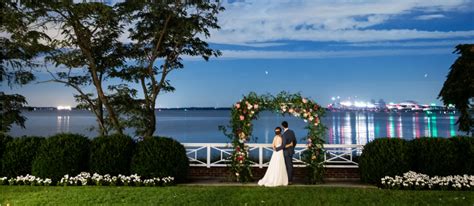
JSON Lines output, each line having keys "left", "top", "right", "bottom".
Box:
{"left": 89, "top": 135, "right": 134, "bottom": 175}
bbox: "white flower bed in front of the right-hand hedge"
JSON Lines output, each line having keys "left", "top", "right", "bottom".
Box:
{"left": 381, "top": 171, "right": 474, "bottom": 190}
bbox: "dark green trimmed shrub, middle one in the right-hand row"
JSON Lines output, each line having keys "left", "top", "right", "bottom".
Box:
{"left": 410, "top": 137, "right": 457, "bottom": 176}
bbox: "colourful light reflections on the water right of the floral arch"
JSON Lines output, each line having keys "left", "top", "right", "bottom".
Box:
{"left": 323, "top": 112, "right": 461, "bottom": 144}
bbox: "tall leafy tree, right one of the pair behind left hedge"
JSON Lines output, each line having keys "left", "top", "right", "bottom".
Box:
{"left": 112, "top": 0, "right": 223, "bottom": 137}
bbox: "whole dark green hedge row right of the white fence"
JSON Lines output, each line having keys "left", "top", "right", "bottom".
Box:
{"left": 359, "top": 137, "right": 474, "bottom": 184}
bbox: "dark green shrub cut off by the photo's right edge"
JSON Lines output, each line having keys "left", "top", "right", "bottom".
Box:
{"left": 451, "top": 136, "right": 474, "bottom": 175}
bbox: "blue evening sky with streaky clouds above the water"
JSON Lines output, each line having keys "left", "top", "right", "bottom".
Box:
{"left": 2, "top": 0, "right": 474, "bottom": 107}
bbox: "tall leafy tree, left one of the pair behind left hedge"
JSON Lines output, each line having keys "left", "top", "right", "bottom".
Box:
{"left": 32, "top": 1, "right": 125, "bottom": 135}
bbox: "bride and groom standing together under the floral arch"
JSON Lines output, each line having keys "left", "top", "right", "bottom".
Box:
{"left": 258, "top": 121, "right": 296, "bottom": 187}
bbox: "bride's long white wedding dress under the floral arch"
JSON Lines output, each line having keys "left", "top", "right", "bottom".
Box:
{"left": 258, "top": 136, "right": 288, "bottom": 187}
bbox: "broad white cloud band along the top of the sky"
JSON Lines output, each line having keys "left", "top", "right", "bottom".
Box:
{"left": 209, "top": 0, "right": 474, "bottom": 44}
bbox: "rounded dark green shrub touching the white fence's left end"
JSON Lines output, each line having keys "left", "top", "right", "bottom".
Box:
{"left": 131, "top": 137, "right": 189, "bottom": 182}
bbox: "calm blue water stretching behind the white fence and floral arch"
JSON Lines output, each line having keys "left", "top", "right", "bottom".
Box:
{"left": 10, "top": 110, "right": 462, "bottom": 144}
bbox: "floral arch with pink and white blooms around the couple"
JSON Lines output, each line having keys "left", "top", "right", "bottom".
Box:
{"left": 220, "top": 92, "right": 326, "bottom": 183}
